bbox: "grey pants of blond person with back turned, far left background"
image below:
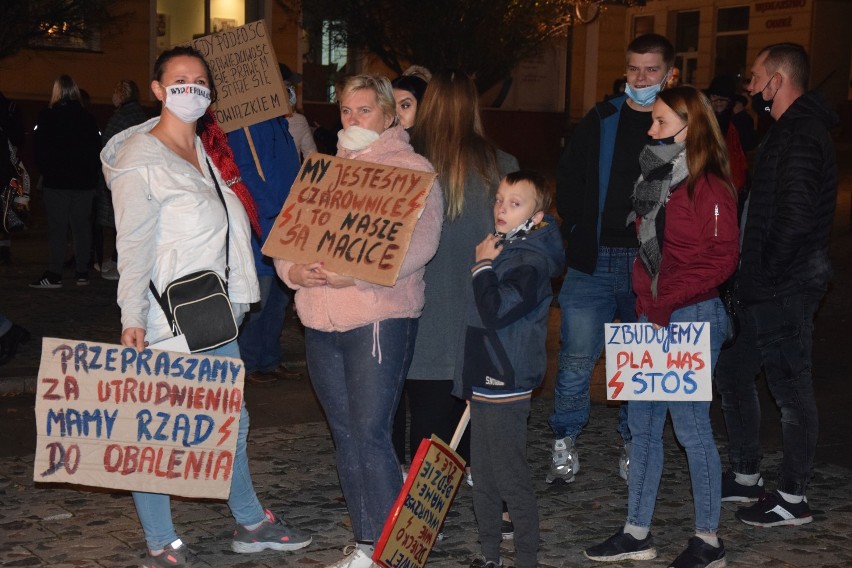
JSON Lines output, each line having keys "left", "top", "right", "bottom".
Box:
{"left": 44, "top": 187, "right": 95, "bottom": 275}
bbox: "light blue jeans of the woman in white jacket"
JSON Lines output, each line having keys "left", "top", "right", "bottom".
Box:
{"left": 133, "top": 341, "right": 266, "bottom": 550}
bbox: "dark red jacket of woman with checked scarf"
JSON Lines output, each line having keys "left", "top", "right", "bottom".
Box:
{"left": 633, "top": 175, "right": 739, "bottom": 325}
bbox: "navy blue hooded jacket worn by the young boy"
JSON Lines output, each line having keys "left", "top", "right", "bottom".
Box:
{"left": 454, "top": 216, "right": 565, "bottom": 398}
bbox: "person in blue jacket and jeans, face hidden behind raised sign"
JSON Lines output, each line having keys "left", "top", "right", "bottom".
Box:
{"left": 228, "top": 116, "right": 299, "bottom": 383}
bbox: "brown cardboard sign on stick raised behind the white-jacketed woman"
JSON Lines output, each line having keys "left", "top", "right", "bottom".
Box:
{"left": 192, "top": 20, "right": 291, "bottom": 132}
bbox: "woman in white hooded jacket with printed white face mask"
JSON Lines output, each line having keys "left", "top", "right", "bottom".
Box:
{"left": 101, "top": 47, "right": 311, "bottom": 568}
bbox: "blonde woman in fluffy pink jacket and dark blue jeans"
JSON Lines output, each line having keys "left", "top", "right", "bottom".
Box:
{"left": 275, "top": 75, "right": 444, "bottom": 568}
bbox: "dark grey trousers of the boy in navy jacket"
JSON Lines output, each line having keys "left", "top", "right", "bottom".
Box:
{"left": 470, "top": 398, "right": 539, "bottom": 568}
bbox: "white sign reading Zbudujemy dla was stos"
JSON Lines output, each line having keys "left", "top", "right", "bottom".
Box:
{"left": 605, "top": 322, "right": 713, "bottom": 401}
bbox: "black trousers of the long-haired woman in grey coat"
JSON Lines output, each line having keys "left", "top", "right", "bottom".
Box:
{"left": 393, "top": 380, "right": 470, "bottom": 465}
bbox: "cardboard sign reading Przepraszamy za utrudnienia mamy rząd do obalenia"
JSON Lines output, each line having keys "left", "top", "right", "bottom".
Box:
{"left": 33, "top": 337, "right": 245, "bottom": 499}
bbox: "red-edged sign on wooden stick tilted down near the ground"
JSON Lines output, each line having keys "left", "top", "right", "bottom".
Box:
{"left": 373, "top": 436, "right": 464, "bottom": 568}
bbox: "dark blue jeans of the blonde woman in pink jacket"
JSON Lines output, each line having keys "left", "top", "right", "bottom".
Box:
{"left": 305, "top": 318, "right": 417, "bottom": 542}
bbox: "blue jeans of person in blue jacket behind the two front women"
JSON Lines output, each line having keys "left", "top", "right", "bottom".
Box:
{"left": 237, "top": 274, "right": 290, "bottom": 374}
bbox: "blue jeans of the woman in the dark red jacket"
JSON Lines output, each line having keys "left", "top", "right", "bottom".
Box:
{"left": 627, "top": 298, "right": 728, "bottom": 533}
